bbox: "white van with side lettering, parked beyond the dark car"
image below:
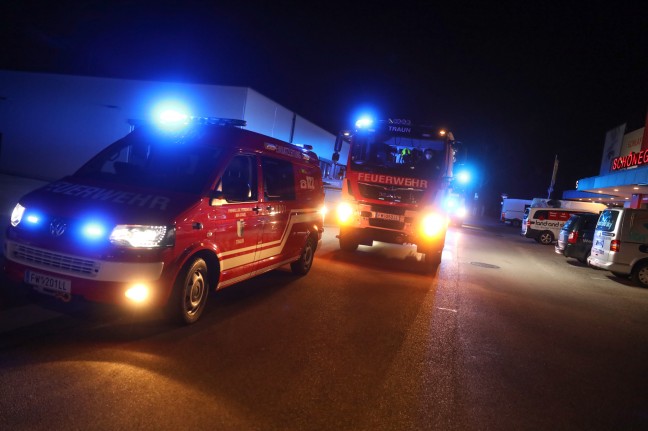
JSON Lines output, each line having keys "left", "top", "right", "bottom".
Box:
{"left": 520, "top": 207, "right": 587, "bottom": 245}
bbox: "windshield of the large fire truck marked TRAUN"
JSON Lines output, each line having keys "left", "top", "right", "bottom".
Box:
{"left": 350, "top": 134, "right": 445, "bottom": 179}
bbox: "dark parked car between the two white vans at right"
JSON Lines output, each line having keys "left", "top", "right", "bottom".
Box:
{"left": 556, "top": 213, "right": 599, "bottom": 263}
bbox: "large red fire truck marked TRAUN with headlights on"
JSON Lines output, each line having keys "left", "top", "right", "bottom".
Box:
{"left": 333, "top": 119, "right": 456, "bottom": 268}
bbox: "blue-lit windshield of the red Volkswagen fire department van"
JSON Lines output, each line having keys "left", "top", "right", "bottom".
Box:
{"left": 75, "top": 130, "right": 222, "bottom": 193}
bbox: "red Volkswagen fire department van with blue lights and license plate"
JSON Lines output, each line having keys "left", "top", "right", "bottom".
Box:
{"left": 4, "top": 118, "right": 324, "bottom": 324}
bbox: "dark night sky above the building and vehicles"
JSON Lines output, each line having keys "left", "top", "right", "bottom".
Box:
{"left": 0, "top": 0, "right": 648, "bottom": 209}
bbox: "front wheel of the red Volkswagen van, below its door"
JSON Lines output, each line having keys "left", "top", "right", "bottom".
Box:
{"left": 167, "top": 257, "right": 209, "bottom": 325}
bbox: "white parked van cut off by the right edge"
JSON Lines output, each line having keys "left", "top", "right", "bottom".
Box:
{"left": 587, "top": 208, "right": 648, "bottom": 287}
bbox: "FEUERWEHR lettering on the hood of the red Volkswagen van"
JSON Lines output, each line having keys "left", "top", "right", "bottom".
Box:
{"left": 45, "top": 181, "right": 171, "bottom": 211}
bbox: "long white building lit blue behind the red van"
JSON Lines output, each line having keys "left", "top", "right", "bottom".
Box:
{"left": 0, "top": 71, "right": 334, "bottom": 180}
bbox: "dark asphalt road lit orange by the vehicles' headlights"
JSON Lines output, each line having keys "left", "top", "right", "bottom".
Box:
{"left": 0, "top": 223, "right": 648, "bottom": 431}
